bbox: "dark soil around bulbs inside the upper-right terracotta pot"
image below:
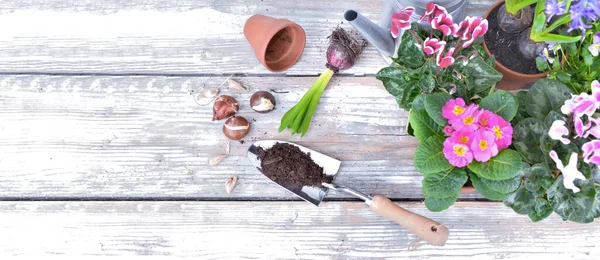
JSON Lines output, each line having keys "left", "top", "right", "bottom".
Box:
{"left": 484, "top": 5, "right": 541, "bottom": 74}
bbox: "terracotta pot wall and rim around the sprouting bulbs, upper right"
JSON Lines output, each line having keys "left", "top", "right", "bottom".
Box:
{"left": 483, "top": 1, "right": 546, "bottom": 90}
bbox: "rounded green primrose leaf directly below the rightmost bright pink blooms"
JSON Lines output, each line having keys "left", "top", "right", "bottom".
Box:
{"left": 468, "top": 149, "right": 521, "bottom": 180}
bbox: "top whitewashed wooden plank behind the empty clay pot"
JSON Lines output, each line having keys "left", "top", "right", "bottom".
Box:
{"left": 0, "top": 0, "right": 494, "bottom": 75}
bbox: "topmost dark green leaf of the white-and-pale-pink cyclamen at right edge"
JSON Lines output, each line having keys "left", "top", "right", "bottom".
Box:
{"left": 525, "top": 79, "right": 572, "bottom": 120}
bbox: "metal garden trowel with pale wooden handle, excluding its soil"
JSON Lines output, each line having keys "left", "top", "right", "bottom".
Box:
{"left": 248, "top": 140, "right": 449, "bottom": 246}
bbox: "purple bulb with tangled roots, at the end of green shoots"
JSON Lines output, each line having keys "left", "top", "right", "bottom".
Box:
{"left": 326, "top": 27, "right": 367, "bottom": 71}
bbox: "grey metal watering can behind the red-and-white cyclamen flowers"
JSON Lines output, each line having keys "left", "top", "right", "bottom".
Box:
{"left": 344, "top": 0, "right": 469, "bottom": 64}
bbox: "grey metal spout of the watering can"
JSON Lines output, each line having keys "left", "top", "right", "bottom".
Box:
{"left": 344, "top": 10, "right": 396, "bottom": 57}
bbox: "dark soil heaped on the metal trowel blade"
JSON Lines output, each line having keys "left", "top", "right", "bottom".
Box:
{"left": 258, "top": 143, "right": 333, "bottom": 189}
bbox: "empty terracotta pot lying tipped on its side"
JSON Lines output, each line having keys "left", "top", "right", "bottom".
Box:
{"left": 244, "top": 14, "right": 306, "bottom": 72}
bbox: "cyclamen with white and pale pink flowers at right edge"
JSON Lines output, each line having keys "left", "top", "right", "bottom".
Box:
{"left": 504, "top": 79, "right": 600, "bottom": 223}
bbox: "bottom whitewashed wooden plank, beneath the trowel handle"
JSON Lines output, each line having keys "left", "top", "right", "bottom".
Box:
{"left": 0, "top": 202, "right": 600, "bottom": 259}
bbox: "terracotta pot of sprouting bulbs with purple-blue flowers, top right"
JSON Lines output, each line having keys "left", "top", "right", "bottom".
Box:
{"left": 484, "top": 0, "right": 600, "bottom": 89}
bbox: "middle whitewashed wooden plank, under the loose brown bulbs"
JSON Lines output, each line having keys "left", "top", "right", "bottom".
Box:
{"left": 0, "top": 75, "right": 486, "bottom": 199}
